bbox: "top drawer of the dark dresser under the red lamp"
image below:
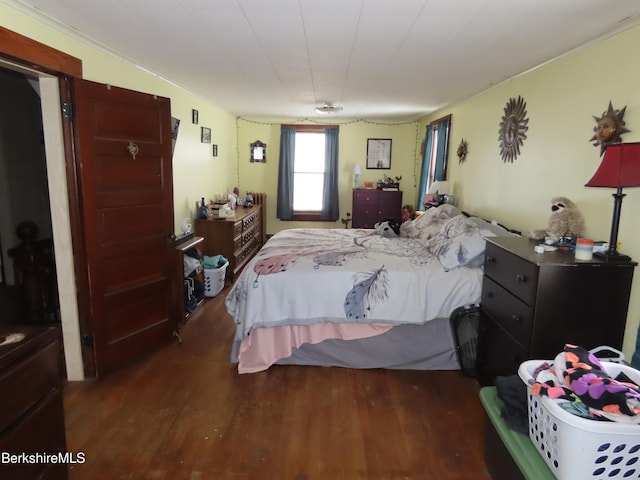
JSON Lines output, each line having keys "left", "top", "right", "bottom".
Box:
{"left": 484, "top": 242, "right": 538, "bottom": 305}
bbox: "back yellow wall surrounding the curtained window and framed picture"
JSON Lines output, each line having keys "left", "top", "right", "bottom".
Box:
{"left": 237, "top": 118, "right": 424, "bottom": 234}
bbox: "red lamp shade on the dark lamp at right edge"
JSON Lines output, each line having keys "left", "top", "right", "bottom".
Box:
{"left": 585, "top": 142, "right": 640, "bottom": 188}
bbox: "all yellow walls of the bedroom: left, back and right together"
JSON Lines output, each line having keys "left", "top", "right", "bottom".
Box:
{"left": 0, "top": 0, "right": 640, "bottom": 356}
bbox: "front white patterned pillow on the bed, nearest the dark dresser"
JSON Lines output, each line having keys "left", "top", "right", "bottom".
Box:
{"left": 426, "top": 215, "right": 494, "bottom": 271}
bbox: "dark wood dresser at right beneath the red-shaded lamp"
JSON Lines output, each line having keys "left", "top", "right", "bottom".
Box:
{"left": 477, "top": 237, "right": 637, "bottom": 385}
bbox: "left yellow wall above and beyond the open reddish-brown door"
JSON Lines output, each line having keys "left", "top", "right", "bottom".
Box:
{"left": 0, "top": 4, "right": 236, "bottom": 232}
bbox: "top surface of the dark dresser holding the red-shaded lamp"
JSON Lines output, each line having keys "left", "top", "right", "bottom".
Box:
{"left": 486, "top": 237, "right": 637, "bottom": 267}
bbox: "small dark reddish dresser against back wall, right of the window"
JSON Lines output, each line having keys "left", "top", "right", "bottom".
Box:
{"left": 352, "top": 189, "right": 402, "bottom": 228}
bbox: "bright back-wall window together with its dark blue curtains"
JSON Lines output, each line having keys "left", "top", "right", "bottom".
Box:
{"left": 277, "top": 125, "right": 339, "bottom": 221}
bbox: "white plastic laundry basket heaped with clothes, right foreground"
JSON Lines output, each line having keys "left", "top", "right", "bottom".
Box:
{"left": 518, "top": 360, "right": 640, "bottom": 480}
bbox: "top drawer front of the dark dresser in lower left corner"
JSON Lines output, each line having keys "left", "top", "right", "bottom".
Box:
{"left": 0, "top": 342, "right": 62, "bottom": 431}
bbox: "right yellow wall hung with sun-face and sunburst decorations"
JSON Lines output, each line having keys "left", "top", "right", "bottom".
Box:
{"left": 421, "top": 27, "right": 640, "bottom": 358}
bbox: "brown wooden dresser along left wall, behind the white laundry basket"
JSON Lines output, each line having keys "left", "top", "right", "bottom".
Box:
{"left": 195, "top": 205, "right": 263, "bottom": 281}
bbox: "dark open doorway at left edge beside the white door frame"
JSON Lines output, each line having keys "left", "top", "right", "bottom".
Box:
{"left": 0, "top": 68, "right": 60, "bottom": 326}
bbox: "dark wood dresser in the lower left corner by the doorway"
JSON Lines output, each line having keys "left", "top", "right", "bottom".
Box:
{"left": 0, "top": 326, "right": 67, "bottom": 480}
